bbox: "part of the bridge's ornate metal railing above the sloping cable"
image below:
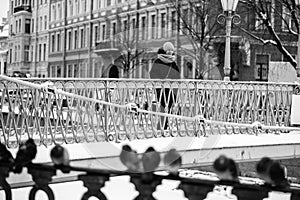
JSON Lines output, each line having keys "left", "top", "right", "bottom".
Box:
{"left": 26, "top": 79, "right": 296, "bottom": 125}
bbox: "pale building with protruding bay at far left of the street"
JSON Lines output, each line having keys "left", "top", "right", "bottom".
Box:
{"left": 8, "top": 0, "right": 50, "bottom": 77}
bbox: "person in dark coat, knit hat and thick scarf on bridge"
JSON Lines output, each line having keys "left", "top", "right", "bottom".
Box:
{"left": 150, "top": 42, "right": 180, "bottom": 130}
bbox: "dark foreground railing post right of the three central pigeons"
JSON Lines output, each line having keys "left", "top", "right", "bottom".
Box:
{"left": 178, "top": 181, "right": 215, "bottom": 200}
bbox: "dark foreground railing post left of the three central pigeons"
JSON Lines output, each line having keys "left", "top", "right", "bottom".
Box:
{"left": 78, "top": 174, "right": 109, "bottom": 200}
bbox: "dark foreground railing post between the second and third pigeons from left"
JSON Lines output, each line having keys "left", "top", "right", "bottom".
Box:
{"left": 28, "top": 166, "right": 56, "bottom": 200}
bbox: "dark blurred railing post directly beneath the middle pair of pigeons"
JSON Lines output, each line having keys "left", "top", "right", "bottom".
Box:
{"left": 130, "top": 172, "right": 161, "bottom": 200}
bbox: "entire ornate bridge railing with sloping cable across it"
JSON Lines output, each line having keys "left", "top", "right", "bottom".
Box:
{"left": 0, "top": 76, "right": 299, "bottom": 148}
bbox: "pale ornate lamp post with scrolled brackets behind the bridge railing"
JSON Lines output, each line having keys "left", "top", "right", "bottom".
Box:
{"left": 218, "top": 0, "right": 240, "bottom": 81}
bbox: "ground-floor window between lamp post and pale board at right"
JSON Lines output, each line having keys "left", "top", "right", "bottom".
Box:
{"left": 256, "top": 55, "right": 269, "bottom": 81}
